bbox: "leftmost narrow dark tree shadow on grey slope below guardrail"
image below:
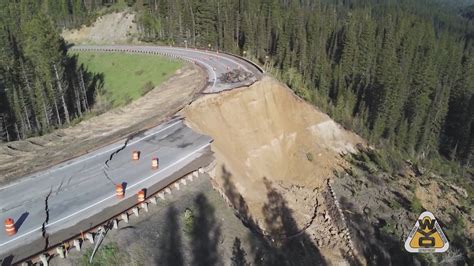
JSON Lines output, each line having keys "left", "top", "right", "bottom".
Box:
{"left": 155, "top": 205, "right": 184, "bottom": 266}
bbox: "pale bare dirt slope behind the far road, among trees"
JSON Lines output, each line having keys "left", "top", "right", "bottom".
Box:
{"left": 61, "top": 12, "right": 138, "bottom": 44}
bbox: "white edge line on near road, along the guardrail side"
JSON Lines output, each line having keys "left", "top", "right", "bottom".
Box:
{"left": 0, "top": 143, "right": 211, "bottom": 247}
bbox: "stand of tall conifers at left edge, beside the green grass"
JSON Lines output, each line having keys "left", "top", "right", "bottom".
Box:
{"left": 0, "top": 0, "right": 103, "bottom": 141}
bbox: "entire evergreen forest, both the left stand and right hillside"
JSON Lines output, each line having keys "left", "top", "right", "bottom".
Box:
{"left": 0, "top": 0, "right": 474, "bottom": 165}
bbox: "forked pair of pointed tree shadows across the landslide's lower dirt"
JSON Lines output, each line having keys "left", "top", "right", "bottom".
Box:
{"left": 222, "top": 166, "right": 326, "bottom": 265}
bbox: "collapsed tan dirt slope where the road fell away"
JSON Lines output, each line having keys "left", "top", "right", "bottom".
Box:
{"left": 183, "top": 77, "right": 363, "bottom": 259}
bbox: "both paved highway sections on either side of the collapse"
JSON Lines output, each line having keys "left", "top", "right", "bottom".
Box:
{"left": 0, "top": 46, "right": 262, "bottom": 263}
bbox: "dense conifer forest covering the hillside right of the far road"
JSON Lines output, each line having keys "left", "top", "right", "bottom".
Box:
{"left": 137, "top": 0, "right": 474, "bottom": 165}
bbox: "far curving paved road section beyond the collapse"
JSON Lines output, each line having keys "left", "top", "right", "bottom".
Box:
{"left": 71, "top": 45, "right": 262, "bottom": 93}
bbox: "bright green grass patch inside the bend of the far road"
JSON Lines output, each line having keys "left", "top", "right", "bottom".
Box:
{"left": 73, "top": 52, "right": 183, "bottom": 107}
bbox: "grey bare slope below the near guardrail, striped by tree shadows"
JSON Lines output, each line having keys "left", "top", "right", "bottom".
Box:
{"left": 51, "top": 177, "right": 268, "bottom": 265}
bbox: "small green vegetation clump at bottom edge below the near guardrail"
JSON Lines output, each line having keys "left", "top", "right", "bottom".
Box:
{"left": 79, "top": 243, "right": 127, "bottom": 266}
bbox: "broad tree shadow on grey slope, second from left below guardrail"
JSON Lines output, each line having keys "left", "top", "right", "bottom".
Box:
{"left": 191, "top": 193, "right": 222, "bottom": 266}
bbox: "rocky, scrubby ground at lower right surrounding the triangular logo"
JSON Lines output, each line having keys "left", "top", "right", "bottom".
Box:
{"left": 332, "top": 149, "right": 474, "bottom": 265}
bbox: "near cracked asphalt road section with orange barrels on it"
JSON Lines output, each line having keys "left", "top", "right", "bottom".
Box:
{"left": 0, "top": 120, "right": 212, "bottom": 256}
